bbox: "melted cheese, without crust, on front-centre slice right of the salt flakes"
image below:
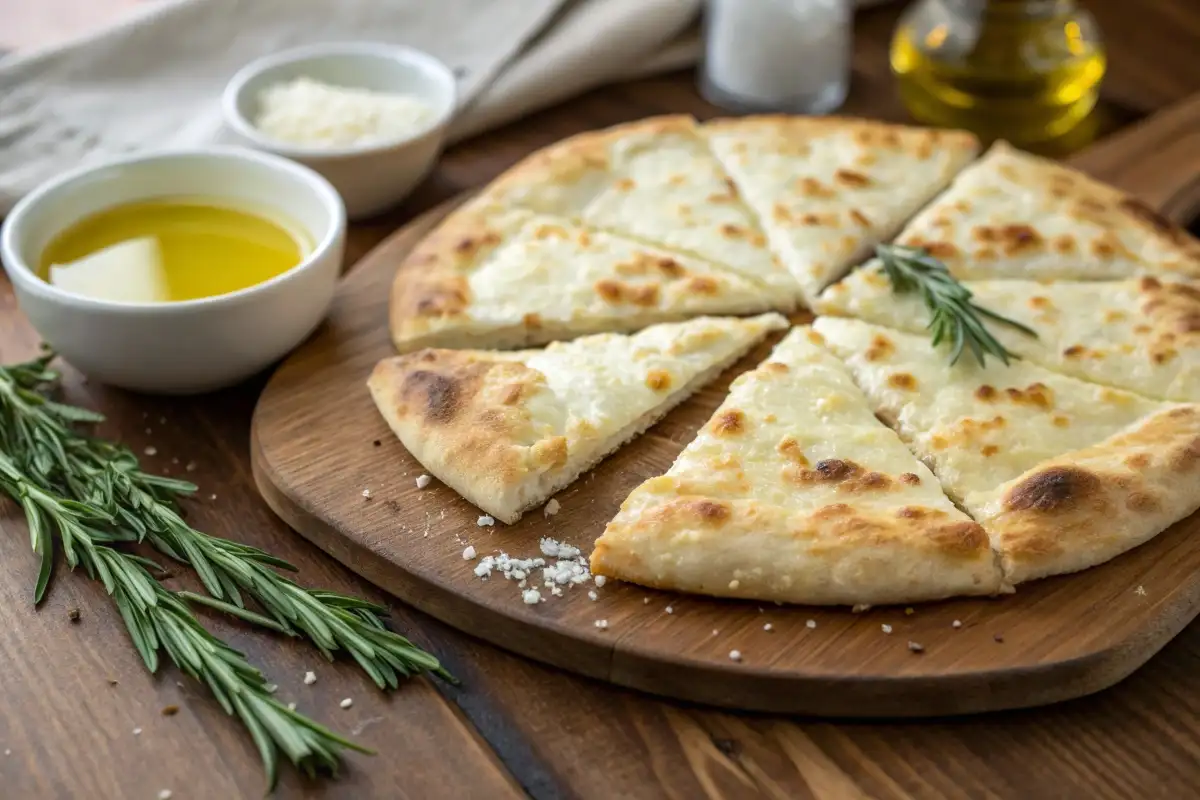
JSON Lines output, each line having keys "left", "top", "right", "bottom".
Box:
{"left": 625, "top": 327, "right": 966, "bottom": 521}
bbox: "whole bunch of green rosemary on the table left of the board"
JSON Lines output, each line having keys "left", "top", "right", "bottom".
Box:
{"left": 0, "top": 354, "right": 454, "bottom": 787}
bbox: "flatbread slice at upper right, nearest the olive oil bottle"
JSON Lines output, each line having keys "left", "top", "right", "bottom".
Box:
{"left": 898, "top": 142, "right": 1200, "bottom": 281}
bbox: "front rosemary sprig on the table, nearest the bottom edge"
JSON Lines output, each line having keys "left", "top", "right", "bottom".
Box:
{"left": 0, "top": 453, "right": 371, "bottom": 788}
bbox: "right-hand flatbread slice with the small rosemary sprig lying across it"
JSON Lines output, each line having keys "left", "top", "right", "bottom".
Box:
{"left": 817, "top": 264, "right": 1200, "bottom": 403}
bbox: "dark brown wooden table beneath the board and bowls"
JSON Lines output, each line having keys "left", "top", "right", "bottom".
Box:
{"left": 0, "top": 0, "right": 1200, "bottom": 799}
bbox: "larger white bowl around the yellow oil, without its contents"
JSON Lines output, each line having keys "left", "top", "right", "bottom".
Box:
{"left": 0, "top": 148, "right": 346, "bottom": 395}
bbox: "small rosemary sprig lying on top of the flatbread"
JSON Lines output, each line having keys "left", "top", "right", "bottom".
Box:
{"left": 875, "top": 245, "right": 1038, "bottom": 366}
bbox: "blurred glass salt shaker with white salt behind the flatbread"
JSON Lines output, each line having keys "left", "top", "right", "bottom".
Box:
{"left": 700, "top": 0, "right": 853, "bottom": 114}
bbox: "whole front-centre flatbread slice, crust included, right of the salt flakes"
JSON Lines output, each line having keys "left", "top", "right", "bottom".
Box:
{"left": 590, "top": 327, "right": 1004, "bottom": 606}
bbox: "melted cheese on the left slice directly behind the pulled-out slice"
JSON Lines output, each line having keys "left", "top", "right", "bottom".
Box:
{"left": 455, "top": 213, "right": 779, "bottom": 330}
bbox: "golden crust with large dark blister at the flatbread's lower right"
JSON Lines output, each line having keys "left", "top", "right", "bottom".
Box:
{"left": 967, "top": 404, "right": 1200, "bottom": 584}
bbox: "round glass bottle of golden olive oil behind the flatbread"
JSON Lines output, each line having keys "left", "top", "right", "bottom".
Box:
{"left": 892, "top": 0, "right": 1106, "bottom": 148}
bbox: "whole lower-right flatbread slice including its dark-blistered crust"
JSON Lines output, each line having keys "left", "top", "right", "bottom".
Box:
{"left": 814, "top": 317, "right": 1200, "bottom": 584}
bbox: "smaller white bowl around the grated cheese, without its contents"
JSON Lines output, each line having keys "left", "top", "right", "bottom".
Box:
{"left": 222, "top": 42, "right": 457, "bottom": 219}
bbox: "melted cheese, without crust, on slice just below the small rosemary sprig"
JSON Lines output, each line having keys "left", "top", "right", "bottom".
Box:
{"left": 814, "top": 317, "right": 1168, "bottom": 511}
